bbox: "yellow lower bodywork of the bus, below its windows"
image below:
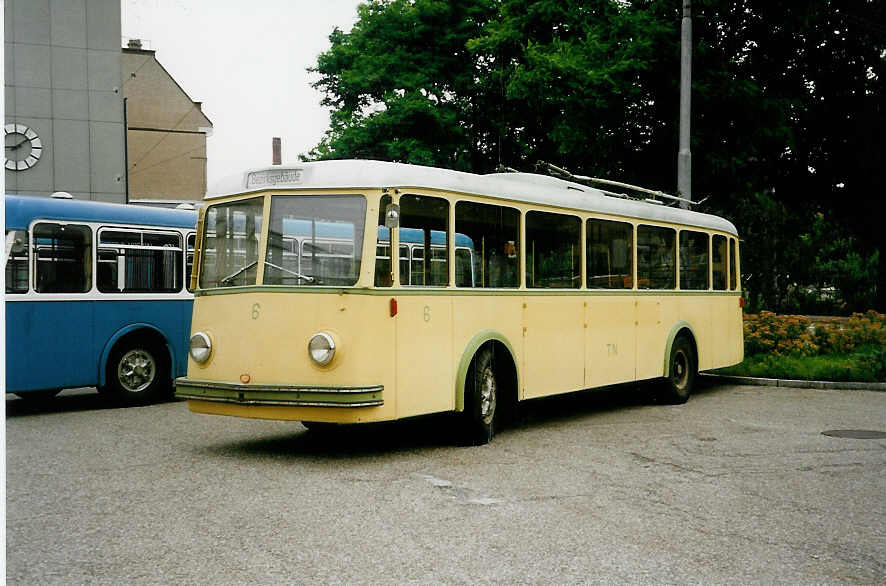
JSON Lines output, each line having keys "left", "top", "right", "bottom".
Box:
{"left": 188, "top": 288, "right": 743, "bottom": 423}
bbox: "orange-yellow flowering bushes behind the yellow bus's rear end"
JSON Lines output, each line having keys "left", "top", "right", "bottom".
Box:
{"left": 744, "top": 311, "right": 886, "bottom": 356}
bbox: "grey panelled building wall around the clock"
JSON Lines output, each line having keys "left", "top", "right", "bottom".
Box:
{"left": 4, "top": 0, "right": 126, "bottom": 202}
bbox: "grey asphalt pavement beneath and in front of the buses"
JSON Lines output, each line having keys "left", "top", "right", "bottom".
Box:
{"left": 6, "top": 384, "right": 886, "bottom": 585}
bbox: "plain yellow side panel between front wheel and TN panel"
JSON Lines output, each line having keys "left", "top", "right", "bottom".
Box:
{"left": 523, "top": 295, "right": 585, "bottom": 399}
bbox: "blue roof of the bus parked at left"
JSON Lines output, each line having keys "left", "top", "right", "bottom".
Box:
{"left": 5, "top": 194, "right": 197, "bottom": 230}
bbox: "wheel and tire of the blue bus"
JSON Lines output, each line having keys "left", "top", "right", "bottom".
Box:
{"left": 107, "top": 338, "right": 172, "bottom": 405}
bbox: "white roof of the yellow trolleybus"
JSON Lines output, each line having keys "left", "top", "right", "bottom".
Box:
{"left": 206, "top": 160, "right": 738, "bottom": 235}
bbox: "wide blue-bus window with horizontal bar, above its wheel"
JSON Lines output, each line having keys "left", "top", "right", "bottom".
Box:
{"left": 96, "top": 229, "right": 183, "bottom": 293}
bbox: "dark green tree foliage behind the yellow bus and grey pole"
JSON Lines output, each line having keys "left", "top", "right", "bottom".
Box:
{"left": 305, "top": 0, "right": 886, "bottom": 311}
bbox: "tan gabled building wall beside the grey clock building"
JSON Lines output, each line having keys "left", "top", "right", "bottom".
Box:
{"left": 122, "top": 48, "right": 212, "bottom": 200}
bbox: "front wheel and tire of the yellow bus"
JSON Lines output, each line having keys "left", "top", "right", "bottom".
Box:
{"left": 463, "top": 347, "right": 499, "bottom": 446}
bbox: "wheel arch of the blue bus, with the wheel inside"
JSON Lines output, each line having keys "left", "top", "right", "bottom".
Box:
{"left": 99, "top": 326, "right": 175, "bottom": 405}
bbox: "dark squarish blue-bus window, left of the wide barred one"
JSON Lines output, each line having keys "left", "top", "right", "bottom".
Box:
{"left": 33, "top": 223, "right": 92, "bottom": 293}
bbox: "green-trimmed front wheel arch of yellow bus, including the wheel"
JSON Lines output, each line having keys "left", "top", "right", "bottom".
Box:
{"left": 456, "top": 333, "right": 519, "bottom": 445}
